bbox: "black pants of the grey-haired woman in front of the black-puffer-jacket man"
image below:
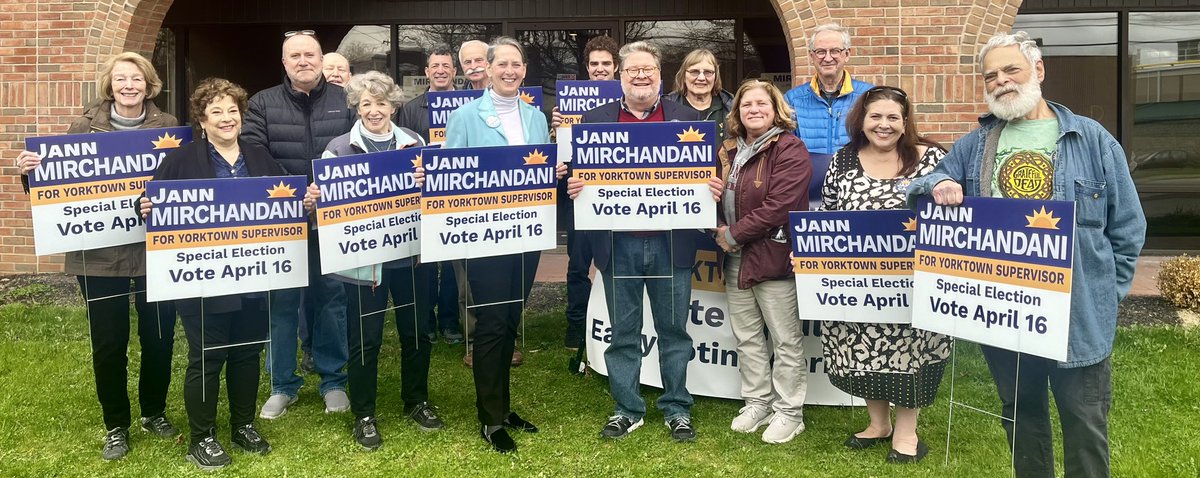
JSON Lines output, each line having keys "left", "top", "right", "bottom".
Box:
{"left": 346, "top": 264, "right": 434, "bottom": 418}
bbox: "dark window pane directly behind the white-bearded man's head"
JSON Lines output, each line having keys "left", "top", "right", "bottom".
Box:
{"left": 1013, "top": 12, "right": 1120, "bottom": 137}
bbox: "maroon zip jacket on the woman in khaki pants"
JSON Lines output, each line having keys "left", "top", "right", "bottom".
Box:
{"left": 716, "top": 132, "right": 812, "bottom": 289}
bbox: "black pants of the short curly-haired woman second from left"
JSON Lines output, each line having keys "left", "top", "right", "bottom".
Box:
{"left": 182, "top": 298, "right": 268, "bottom": 443}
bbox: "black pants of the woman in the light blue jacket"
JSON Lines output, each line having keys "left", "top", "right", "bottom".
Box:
{"left": 466, "top": 252, "right": 541, "bottom": 425}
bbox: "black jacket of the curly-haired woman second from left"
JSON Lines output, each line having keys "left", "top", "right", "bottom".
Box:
{"left": 154, "top": 138, "right": 288, "bottom": 316}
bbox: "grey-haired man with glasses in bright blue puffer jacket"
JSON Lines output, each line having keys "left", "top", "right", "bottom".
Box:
{"left": 784, "top": 23, "right": 875, "bottom": 155}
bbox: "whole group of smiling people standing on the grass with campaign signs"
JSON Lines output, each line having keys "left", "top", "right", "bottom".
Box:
{"left": 18, "top": 19, "right": 1145, "bottom": 477}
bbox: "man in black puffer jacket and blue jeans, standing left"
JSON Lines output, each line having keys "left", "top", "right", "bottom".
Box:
{"left": 241, "top": 30, "right": 355, "bottom": 419}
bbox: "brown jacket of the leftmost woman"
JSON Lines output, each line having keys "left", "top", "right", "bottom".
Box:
{"left": 20, "top": 100, "right": 179, "bottom": 277}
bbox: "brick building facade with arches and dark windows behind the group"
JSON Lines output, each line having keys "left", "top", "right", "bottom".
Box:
{"left": 0, "top": 0, "right": 1200, "bottom": 274}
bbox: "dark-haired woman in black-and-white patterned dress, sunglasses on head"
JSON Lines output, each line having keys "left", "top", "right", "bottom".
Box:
{"left": 821, "top": 86, "right": 950, "bottom": 464}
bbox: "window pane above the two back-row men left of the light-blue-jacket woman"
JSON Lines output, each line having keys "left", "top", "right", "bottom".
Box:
{"left": 396, "top": 23, "right": 502, "bottom": 101}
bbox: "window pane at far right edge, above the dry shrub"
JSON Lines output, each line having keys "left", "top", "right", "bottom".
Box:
{"left": 1128, "top": 12, "right": 1200, "bottom": 249}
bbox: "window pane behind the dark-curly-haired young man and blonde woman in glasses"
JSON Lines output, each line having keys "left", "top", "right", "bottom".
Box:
{"left": 625, "top": 19, "right": 738, "bottom": 97}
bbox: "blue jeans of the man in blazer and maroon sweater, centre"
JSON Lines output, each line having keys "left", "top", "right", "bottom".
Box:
{"left": 601, "top": 232, "right": 692, "bottom": 420}
